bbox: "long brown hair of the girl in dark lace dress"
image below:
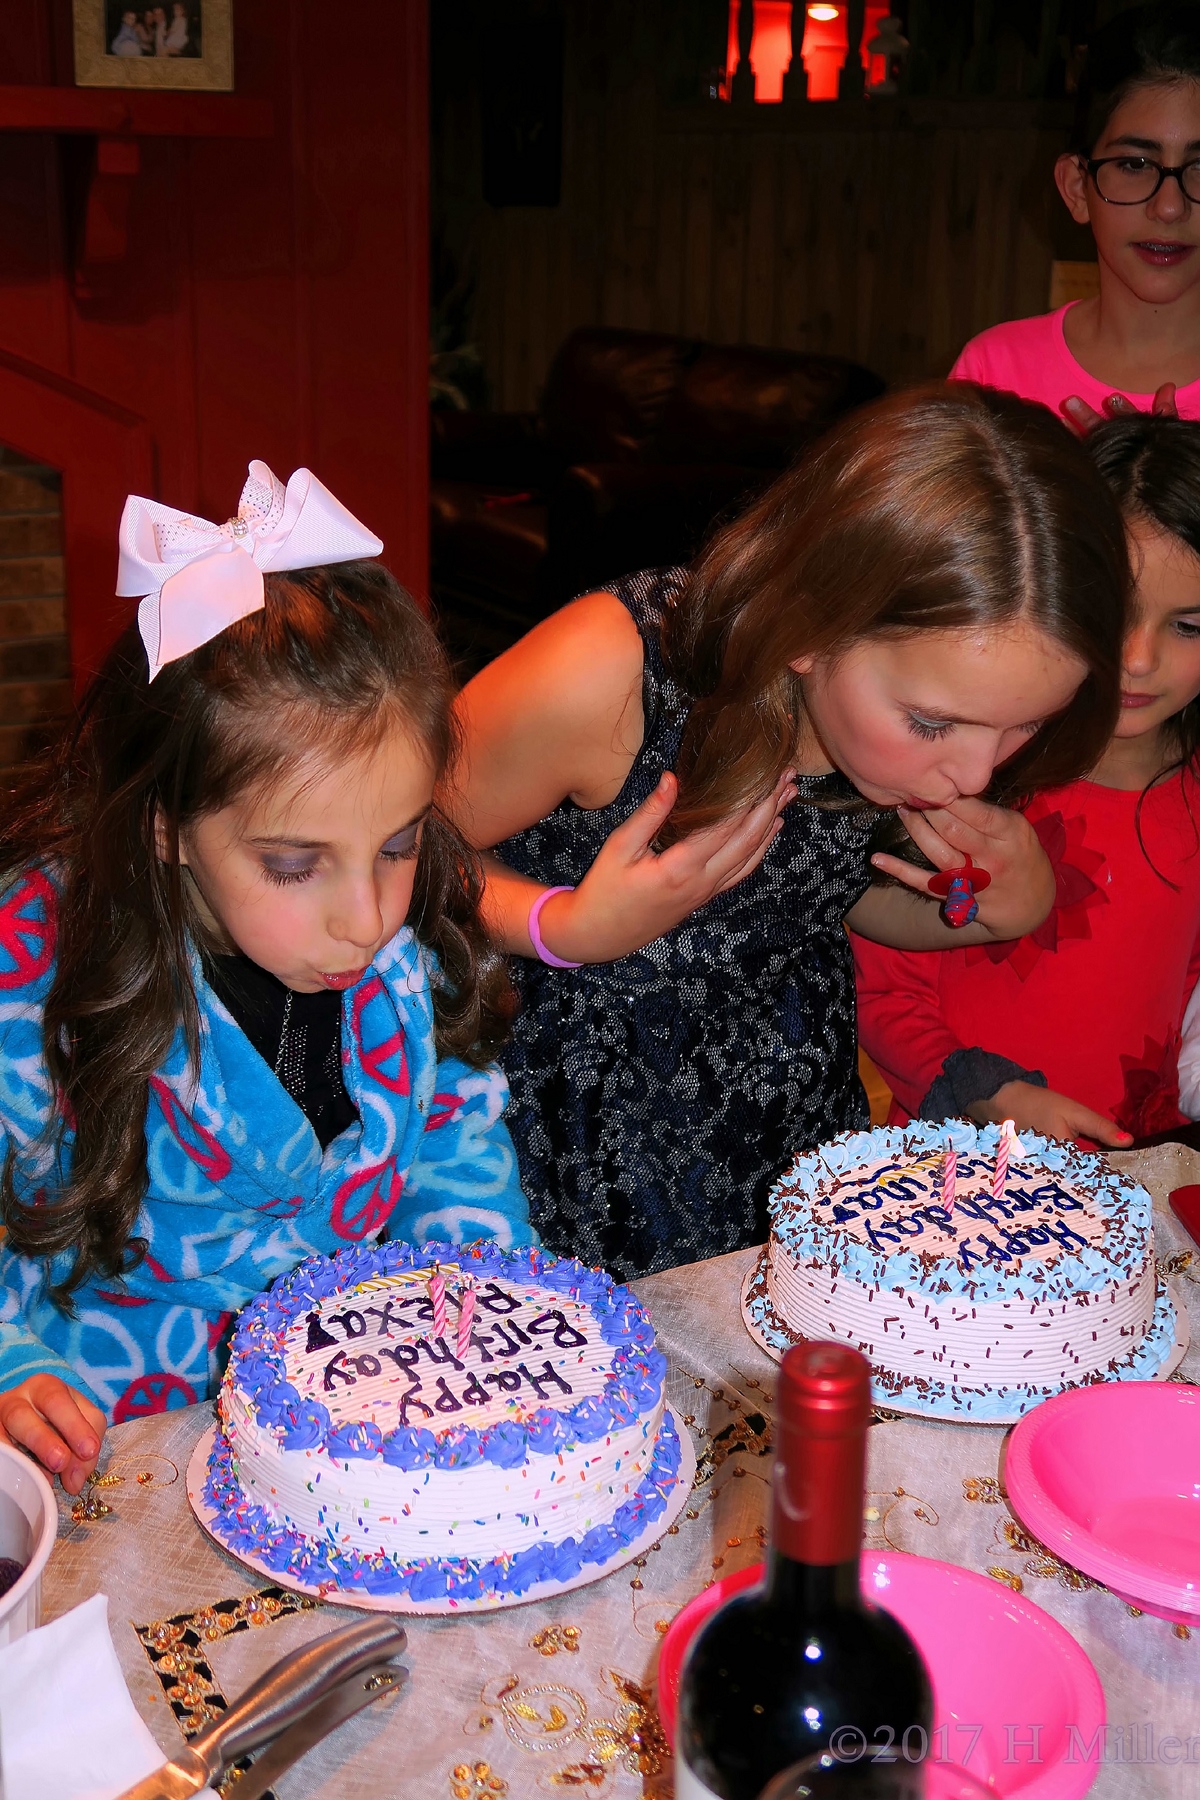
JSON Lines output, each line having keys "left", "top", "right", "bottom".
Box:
{"left": 664, "top": 382, "right": 1130, "bottom": 841}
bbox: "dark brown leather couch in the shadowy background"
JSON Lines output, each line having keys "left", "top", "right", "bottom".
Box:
{"left": 430, "top": 329, "right": 883, "bottom": 671}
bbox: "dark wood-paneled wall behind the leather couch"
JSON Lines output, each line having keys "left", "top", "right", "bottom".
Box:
{"left": 434, "top": 0, "right": 1088, "bottom": 409}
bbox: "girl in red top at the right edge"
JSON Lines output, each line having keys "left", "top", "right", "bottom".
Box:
{"left": 853, "top": 414, "right": 1200, "bottom": 1148}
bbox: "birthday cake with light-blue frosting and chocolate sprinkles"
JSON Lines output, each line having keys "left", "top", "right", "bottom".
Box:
{"left": 745, "top": 1120, "right": 1175, "bottom": 1420}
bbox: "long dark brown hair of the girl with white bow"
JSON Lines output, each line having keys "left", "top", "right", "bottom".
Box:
{"left": 0, "top": 563, "right": 513, "bottom": 1303}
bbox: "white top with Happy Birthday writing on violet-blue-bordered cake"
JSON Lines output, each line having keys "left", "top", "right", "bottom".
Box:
{"left": 293, "top": 1282, "right": 612, "bottom": 1426}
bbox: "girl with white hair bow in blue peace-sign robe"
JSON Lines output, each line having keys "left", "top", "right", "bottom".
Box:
{"left": 0, "top": 463, "right": 536, "bottom": 1492}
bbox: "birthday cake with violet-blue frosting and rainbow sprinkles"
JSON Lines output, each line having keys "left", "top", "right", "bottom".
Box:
{"left": 203, "top": 1242, "right": 680, "bottom": 1604}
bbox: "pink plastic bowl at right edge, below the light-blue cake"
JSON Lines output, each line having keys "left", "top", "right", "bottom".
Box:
{"left": 1006, "top": 1381, "right": 1200, "bottom": 1625}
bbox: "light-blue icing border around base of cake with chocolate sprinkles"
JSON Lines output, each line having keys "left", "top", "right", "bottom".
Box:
{"left": 747, "top": 1253, "right": 1175, "bottom": 1424}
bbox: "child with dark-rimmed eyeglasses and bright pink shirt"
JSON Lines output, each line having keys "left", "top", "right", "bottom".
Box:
{"left": 950, "top": 4, "right": 1200, "bottom": 430}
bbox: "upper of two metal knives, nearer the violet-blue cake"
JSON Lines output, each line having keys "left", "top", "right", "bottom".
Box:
{"left": 119, "top": 1616, "right": 408, "bottom": 1800}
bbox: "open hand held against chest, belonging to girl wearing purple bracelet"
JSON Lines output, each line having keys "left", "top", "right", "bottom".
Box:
{"left": 540, "top": 769, "right": 795, "bottom": 963}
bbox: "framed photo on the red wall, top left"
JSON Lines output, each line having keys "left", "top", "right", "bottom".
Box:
{"left": 72, "top": 0, "right": 234, "bottom": 88}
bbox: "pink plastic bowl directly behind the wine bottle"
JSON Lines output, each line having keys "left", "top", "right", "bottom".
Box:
{"left": 658, "top": 1550, "right": 1105, "bottom": 1800}
